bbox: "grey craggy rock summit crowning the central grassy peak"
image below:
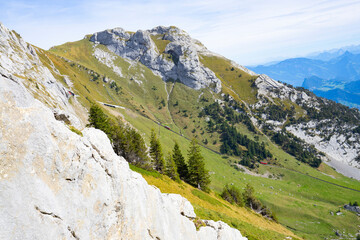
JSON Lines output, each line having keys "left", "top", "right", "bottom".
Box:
{"left": 90, "top": 26, "right": 221, "bottom": 92}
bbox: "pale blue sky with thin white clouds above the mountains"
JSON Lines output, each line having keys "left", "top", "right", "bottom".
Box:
{"left": 0, "top": 0, "right": 360, "bottom": 66}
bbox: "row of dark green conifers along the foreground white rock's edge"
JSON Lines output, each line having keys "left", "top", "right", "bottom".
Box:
{"left": 88, "top": 105, "right": 210, "bottom": 191}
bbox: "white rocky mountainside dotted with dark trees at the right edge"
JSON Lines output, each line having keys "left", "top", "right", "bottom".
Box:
{"left": 256, "top": 75, "right": 360, "bottom": 176}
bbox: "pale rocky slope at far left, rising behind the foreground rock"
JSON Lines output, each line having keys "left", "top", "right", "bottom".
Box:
{"left": 0, "top": 23, "right": 81, "bottom": 122}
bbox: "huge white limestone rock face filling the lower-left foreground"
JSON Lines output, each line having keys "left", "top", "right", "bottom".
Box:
{"left": 0, "top": 22, "right": 246, "bottom": 240}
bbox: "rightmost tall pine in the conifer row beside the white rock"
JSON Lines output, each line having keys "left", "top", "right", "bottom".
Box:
{"left": 188, "top": 139, "right": 210, "bottom": 191}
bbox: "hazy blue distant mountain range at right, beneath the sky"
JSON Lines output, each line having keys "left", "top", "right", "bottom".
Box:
{"left": 249, "top": 45, "right": 360, "bottom": 108}
